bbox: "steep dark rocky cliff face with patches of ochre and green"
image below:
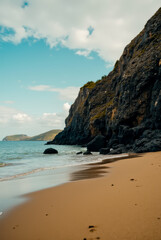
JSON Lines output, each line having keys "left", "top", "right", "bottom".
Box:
{"left": 54, "top": 8, "right": 161, "bottom": 152}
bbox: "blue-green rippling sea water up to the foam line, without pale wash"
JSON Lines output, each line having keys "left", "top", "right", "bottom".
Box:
{"left": 0, "top": 141, "right": 112, "bottom": 182}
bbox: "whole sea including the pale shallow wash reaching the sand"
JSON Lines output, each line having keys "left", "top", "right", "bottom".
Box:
{"left": 0, "top": 141, "right": 119, "bottom": 212}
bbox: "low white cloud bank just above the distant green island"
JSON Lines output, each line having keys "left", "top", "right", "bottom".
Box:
{"left": 0, "top": 102, "right": 70, "bottom": 139}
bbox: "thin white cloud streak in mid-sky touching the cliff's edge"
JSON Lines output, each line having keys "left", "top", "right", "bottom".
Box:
{"left": 29, "top": 85, "right": 80, "bottom": 101}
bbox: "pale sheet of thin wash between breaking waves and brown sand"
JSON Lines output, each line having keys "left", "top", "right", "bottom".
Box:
{"left": 0, "top": 154, "right": 128, "bottom": 212}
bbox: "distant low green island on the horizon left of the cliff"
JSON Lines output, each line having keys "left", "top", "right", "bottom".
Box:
{"left": 2, "top": 129, "right": 62, "bottom": 141}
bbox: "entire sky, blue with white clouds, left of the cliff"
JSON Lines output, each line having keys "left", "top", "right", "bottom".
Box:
{"left": 0, "top": 0, "right": 160, "bottom": 140}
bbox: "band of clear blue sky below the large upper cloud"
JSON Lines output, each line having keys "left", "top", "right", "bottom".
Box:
{"left": 0, "top": 40, "right": 108, "bottom": 115}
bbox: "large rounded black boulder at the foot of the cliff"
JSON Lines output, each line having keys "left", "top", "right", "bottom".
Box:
{"left": 87, "top": 135, "right": 106, "bottom": 152}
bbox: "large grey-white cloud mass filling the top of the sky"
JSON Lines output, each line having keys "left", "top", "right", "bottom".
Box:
{"left": 0, "top": 0, "right": 160, "bottom": 62}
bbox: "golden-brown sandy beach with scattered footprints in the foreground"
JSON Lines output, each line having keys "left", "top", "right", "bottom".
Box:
{"left": 0, "top": 152, "right": 161, "bottom": 240}
